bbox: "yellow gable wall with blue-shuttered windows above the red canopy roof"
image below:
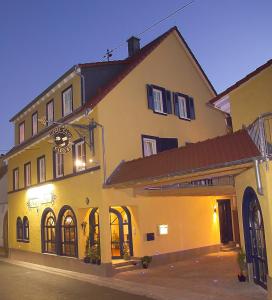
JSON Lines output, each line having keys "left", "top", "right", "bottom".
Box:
{"left": 96, "top": 33, "right": 226, "bottom": 174}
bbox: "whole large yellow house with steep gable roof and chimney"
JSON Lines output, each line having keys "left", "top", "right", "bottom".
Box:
{"left": 6, "top": 28, "right": 230, "bottom": 274}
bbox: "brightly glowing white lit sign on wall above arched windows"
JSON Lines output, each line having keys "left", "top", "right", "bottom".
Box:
{"left": 27, "top": 184, "right": 55, "bottom": 208}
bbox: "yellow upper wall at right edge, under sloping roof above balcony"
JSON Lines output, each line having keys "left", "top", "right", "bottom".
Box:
{"left": 230, "top": 66, "right": 272, "bottom": 131}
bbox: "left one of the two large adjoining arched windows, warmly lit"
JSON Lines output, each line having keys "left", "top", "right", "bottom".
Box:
{"left": 41, "top": 208, "right": 56, "bottom": 254}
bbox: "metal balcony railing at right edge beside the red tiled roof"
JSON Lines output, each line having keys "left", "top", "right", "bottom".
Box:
{"left": 247, "top": 112, "right": 272, "bottom": 159}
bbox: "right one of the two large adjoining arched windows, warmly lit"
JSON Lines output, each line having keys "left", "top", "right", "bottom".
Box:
{"left": 58, "top": 206, "right": 77, "bottom": 257}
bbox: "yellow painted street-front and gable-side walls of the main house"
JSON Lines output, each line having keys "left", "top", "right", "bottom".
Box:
{"left": 8, "top": 28, "right": 226, "bottom": 262}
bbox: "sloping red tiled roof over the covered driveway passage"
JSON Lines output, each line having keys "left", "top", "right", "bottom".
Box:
{"left": 107, "top": 129, "right": 260, "bottom": 185}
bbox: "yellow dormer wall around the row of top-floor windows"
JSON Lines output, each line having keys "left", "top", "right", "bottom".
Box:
{"left": 14, "top": 76, "right": 81, "bottom": 145}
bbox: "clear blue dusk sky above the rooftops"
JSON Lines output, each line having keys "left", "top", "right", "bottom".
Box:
{"left": 0, "top": 0, "right": 272, "bottom": 153}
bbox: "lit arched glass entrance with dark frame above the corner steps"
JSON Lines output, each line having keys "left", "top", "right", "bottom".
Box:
{"left": 110, "top": 206, "right": 133, "bottom": 259}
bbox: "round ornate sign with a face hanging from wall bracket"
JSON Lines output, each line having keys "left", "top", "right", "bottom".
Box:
{"left": 50, "top": 126, "right": 72, "bottom": 153}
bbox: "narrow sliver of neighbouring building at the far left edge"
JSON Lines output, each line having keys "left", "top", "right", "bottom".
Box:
{"left": 0, "top": 156, "right": 8, "bottom": 254}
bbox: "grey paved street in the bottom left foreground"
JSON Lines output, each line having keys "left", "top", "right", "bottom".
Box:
{"left": 0, "top": 262, "right": 150, "bottom": 300}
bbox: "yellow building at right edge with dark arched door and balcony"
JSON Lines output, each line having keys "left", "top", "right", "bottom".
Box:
{"left": 210, "top": 60, "right": 272, "bottom": 299}
